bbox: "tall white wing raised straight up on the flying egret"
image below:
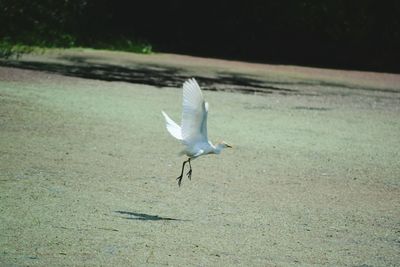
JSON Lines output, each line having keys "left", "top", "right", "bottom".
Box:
{"left": 181, "top": 79, "right": 208, "bottom": 144}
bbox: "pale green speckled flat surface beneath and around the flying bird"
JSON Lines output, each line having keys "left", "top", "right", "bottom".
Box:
{"left": 0, "top": 50, "right": 400, "bottom": 266}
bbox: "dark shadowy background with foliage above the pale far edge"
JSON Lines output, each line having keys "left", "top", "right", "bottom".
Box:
{"left": 0, "top": 0, "right": 400, "bottom": 72}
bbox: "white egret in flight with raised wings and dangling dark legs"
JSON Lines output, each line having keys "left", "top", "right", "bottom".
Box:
{"left": 161, "top": 78, "right": 232, "bottom": 186}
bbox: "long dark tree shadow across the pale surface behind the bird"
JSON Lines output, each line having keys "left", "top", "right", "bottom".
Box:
{"left": 0, "top": 56, "right": 297, "bottom": 94}
